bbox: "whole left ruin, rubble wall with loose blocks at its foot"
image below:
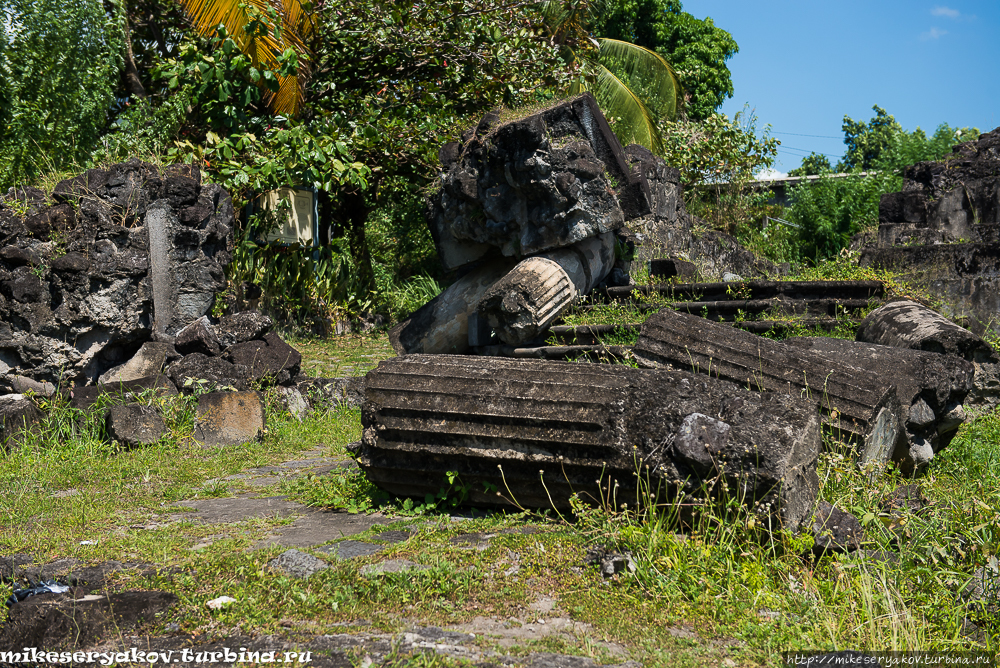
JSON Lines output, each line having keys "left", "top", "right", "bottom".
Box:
{"left": 0, "top": 159, "right": 347, "bottom": 447}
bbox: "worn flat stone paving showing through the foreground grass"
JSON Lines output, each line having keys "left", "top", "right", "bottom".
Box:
{"left": 0, "top": 449, "right": 664, "bottom": 668}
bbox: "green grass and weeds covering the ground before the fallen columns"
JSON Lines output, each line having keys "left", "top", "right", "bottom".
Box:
{"left": 0, "top": 332, "right": 1000, "bottom": 666}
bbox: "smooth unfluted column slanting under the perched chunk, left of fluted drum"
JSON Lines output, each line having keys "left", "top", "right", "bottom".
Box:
{"left": 389, "top": 259, "right": 514, "bottom": 355}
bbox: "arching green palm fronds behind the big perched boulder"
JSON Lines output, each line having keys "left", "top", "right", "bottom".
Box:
{"left": 542, "top": 0, "right": 680, "bottom": 153}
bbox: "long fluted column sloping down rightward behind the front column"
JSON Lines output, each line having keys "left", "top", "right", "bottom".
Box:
{"left": 633, "top": 309, "right": 903, "bottom": 464}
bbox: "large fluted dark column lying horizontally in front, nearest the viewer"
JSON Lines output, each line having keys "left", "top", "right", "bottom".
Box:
{"left": 358, "top": 355, "right": 820, "bottom": 529}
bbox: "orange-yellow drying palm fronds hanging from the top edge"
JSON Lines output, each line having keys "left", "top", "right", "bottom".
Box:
{"left": 177, "top": 0, "right": 315, "bottom": 118}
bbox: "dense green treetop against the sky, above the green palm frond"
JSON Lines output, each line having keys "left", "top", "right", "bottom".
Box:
{"left": 594, "top": 0, "right": 739, "bottom": 120}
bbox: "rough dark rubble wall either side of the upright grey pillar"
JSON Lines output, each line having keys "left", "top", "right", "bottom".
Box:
{"left": 0, "top": 160, "right": 234, "bottom": 386}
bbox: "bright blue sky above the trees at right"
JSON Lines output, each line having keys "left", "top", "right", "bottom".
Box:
{"left": 683, "top": 0, "right": 1000, "bottom": 172}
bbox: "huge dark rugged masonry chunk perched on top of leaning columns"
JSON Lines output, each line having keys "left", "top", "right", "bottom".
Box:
{"left": 428, "top": 93, "right": 649, "bottom": 269}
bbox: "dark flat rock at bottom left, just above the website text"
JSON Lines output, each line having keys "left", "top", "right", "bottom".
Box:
{"left": 0, "top": 589, "right": 177, "bottom": 652}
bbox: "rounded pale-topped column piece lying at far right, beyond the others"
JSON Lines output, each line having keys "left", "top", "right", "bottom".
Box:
{"left": 856, "top": 300, "right": 998, "bottom": 362}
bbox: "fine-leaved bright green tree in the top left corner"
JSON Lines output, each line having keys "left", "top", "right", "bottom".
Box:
{"left": 0, "top": 0, "right": 124, "bottom": 188}
